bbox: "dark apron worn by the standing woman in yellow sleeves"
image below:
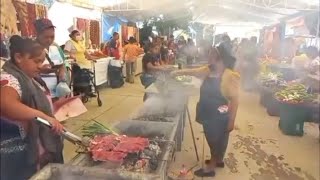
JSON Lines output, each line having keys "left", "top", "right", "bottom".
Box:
{"left": 197, "top": 76, "right": 229, "bottom": 161}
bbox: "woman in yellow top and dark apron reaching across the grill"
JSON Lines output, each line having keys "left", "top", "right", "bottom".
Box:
{"left": 172, "top": 46, "right": 240, "bottom": 177}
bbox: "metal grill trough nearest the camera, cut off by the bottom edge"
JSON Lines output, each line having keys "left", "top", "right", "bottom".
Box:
{"left": 30, "top": 164, "right": 160, "bottom": 180}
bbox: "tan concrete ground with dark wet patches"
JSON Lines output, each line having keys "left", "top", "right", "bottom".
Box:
{"left": 64, "top": 79, "right": 320, "bottom": 180}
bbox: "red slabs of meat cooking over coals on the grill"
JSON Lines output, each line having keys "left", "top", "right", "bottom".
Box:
{"left": 89, "top": 135, "right": 161, "bottom": 172}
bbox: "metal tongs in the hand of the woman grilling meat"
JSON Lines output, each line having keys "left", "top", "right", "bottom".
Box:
{"left": 35, "top": 117, "right": 90, "bottom": 147}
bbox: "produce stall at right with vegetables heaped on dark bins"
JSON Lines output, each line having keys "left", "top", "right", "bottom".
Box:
{"left": 257, "top": 59, "right": 319, "bottom": 136}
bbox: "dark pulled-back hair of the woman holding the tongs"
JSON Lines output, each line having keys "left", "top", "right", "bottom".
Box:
{"left": 9, "top": 35, "right": 44, "bottom": 62}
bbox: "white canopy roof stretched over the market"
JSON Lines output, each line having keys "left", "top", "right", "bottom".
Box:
{"left": 51, "top": 0, "right": 319, "bottom": 37}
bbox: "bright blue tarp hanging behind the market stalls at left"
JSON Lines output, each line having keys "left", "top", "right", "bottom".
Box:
{"left": 102, "top": 14, "right": 126, "bottom": 42}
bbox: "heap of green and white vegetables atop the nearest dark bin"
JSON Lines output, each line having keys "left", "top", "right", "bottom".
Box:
{"left": 275, "top": 83, "right": 314, "bottom": 104}
